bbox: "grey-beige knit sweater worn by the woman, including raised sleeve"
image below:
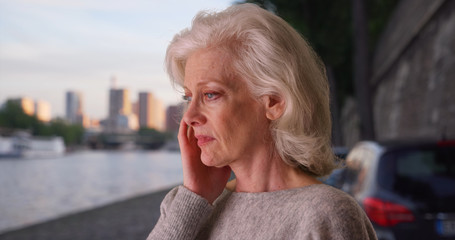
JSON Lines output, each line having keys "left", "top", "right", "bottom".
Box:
{"left": 147, "top": 184, "right": 376, "bottom": 240}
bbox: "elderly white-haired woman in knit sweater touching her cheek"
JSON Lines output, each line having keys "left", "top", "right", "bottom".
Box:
{"left": 148, "top": 4, "right": 376, "bottom": 239}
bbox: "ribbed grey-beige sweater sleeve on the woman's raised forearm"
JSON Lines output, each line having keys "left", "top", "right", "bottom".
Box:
{"left": 147, "top": 186, "right": 213, "bottom": 240}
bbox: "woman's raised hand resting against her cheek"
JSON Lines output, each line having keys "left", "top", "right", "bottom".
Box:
{"left": 178, "top": 120, "right": 231, "bottom": 204}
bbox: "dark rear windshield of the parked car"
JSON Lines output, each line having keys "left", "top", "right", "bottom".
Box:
{"left": 378, "top": 146, "right": 455, "bottom": 200}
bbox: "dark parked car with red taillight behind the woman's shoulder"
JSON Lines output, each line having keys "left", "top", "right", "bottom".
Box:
{"left": 341, "top": 141, "right": 455, "bottom": 240}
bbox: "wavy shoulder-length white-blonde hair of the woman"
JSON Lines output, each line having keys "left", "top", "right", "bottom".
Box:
{"left": 165, "top": 4, "right": 336, "bottom": 176}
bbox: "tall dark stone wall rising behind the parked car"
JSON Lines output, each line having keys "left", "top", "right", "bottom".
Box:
{"left": 371, "top": 0, "right": 455, "bottom": 140}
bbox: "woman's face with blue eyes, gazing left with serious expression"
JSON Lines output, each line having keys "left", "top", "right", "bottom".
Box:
{"left": 183, "top": 49, "right": 270, "bottom": 167}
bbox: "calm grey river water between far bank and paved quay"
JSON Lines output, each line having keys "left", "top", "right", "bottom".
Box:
{"left": 0, "top": 151, "right": 183, "bottom": 233}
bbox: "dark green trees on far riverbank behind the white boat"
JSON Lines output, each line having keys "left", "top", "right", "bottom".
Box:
{"left": 0, "top": 100, "right": 84, "bottom": 145}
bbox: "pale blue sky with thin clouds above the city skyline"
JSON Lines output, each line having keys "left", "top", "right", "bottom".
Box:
{"left": 0, "top": 0, "right": 233, "bottom": 119}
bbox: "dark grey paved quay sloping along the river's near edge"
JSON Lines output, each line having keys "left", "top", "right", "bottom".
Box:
{"left": 0, "top": 189, "right": 170, "bottom": 240}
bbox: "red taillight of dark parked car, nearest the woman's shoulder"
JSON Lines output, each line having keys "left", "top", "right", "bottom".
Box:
{"left": 363, "top": 198, "right": 415, "bottom": 227}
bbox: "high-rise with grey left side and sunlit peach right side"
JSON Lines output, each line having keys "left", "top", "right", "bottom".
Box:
{"left": 138, "top": 92, "right": 165, "bottom": 131}
